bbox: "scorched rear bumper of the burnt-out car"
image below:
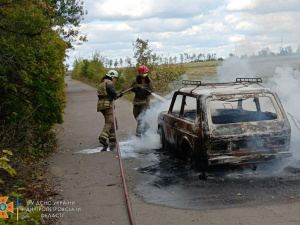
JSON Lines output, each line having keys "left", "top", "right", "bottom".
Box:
{"left": 208, "top": 152, "right": 292, "bottom": 165}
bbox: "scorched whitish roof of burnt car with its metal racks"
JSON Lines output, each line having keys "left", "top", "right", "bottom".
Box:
{"left": 178, "top": 78, "right": 274, "bottom": 96}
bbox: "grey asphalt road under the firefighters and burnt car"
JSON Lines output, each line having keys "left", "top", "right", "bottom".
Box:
{"left": 49, "top": 77, "right": 300, "bottom": 225}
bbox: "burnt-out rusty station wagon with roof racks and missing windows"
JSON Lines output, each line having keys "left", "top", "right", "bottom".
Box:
{"left": 158, "top": 78, "right": 291, "bottom": 167}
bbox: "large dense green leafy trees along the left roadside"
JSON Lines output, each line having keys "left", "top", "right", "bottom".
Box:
{"left": 0, "top": 0, "right": 85, "bottom": 155}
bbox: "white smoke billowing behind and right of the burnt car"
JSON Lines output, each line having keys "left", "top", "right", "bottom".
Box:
{"left": 217, "top": 58, "right": 300, "bottom": 159}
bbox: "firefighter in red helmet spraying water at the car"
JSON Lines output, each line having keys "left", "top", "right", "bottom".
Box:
{"left": 131, "top": 65, "right": 153, "bottom": 137}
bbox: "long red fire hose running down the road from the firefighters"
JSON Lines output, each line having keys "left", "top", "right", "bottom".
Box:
{"left": 112, "top": 101, "right": 135, "bottom": 225}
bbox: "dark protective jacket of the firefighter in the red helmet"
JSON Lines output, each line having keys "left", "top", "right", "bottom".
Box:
{"left": 131, "top": 75, "right": 153, "bottom": 105}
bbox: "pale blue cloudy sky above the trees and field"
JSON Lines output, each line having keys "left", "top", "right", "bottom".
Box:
{"left": 66, "top": 0, "right": 300, "bottom": 68}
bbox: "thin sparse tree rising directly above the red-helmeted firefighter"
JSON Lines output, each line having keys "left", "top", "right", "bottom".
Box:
{"left": 132, "top": 38, "right": 152, "bottom": 66}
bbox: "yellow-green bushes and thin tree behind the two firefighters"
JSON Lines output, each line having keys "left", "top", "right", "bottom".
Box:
{"left": 71, "top": 38, "right": 186, "bottom": 93}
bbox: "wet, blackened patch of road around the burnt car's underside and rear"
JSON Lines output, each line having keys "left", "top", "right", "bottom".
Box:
{"left": 134, "top": 149, "right": 300, "bottom": 209}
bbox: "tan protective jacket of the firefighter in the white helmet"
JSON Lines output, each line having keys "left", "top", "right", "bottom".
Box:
{"left": 97, "top": 79, "right": 117, "bottom": 112}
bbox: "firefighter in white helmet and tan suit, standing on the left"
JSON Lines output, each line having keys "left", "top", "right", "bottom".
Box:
{"left": 97, "top": 70, "right": 122, "bottom": 146}
